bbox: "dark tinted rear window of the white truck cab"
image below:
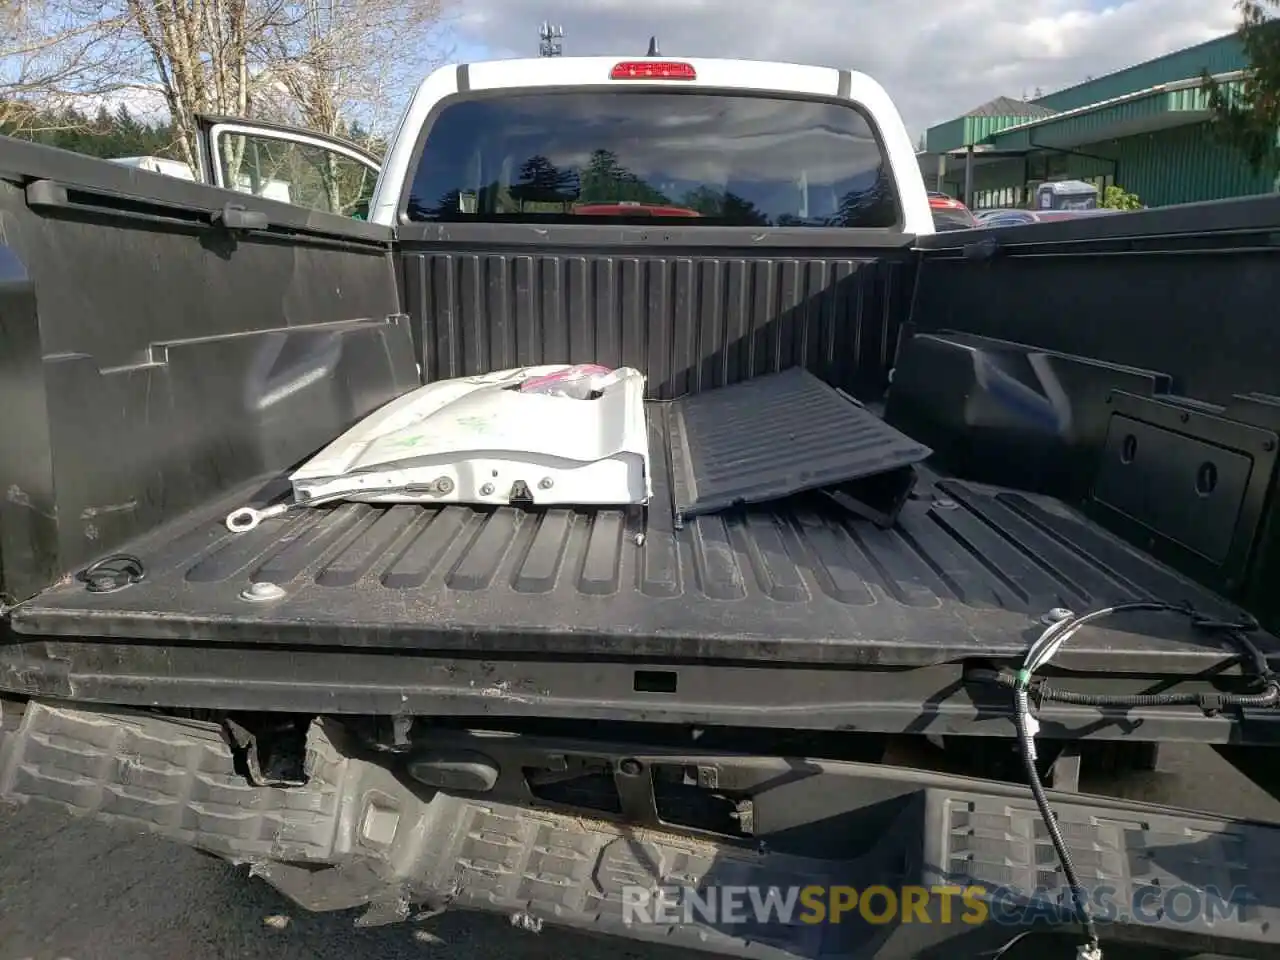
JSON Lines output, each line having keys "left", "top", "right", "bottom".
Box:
{"left": 407, "top": 91, "right": 900, "bottom": 228}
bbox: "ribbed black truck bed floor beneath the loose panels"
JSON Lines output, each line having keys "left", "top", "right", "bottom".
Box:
{"left": 10, "top": 404, "right": 1276, "bottom": 672}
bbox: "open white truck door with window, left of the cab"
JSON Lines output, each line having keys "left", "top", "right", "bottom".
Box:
{"left": 196, "top": 115, "right": 381, "bottom": 220}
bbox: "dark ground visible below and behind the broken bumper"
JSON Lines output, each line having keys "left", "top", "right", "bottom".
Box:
{"left": 0, "top": 745, "right": 1280, "bottom": 960}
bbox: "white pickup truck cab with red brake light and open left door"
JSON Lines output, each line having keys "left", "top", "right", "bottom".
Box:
{"left": 185, "top": 56, "right": 934, "bottom": 234}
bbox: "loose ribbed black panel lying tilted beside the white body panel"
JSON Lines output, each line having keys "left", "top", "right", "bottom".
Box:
{"left": 669, "top": 367, "right": 932, "bottom": 524}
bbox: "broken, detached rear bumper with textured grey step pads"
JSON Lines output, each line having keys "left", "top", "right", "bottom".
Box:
{"left": 0, "top": 701, "right": 1280, "bottom": 960}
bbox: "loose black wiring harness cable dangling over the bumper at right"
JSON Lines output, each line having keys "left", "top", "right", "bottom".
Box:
{"left": 968, "top": 600, "right": 1280, "bottom": 960}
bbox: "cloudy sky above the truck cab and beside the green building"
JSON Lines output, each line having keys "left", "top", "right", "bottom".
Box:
{"left": 437, "top": 0, "right": 1236, "bottom": 137}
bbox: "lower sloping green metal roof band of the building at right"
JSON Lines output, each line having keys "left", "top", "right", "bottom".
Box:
{"left": 982, "top": 73, "right": 1240, "bottom": 151}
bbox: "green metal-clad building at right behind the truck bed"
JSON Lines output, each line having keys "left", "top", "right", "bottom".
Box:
{"left": 918, "top": 35, "right": 1277, "bottom": 209}
